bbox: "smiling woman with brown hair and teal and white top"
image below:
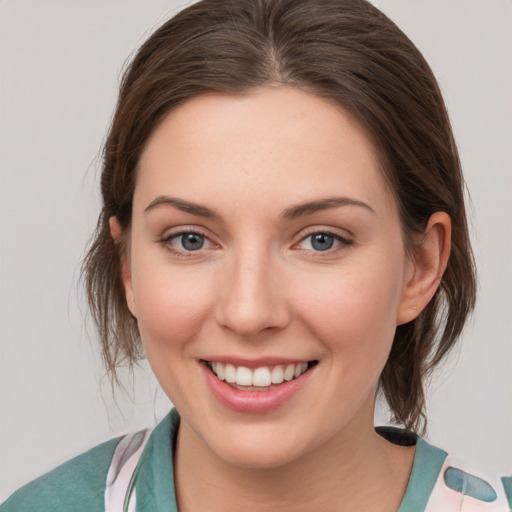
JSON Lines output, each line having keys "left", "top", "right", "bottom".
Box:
{"left": 2, "top": 0, "right": 508, "bottom": 512}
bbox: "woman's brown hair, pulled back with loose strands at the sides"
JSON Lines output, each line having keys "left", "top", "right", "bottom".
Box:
{"left": 83, "top": 0, "right": 476, "bottom": 429}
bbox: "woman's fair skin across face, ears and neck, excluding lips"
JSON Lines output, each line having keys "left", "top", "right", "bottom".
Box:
{"left": 111, "top": 87, "right": 450, "bottom": 512}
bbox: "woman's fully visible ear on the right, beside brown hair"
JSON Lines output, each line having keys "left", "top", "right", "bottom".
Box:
{"left": 396, "top": 212, "right": 452, "bottom": 325}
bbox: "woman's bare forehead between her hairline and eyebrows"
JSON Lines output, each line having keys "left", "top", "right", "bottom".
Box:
{"left": 135, "top": 87, "right": 393, "bottom": 216}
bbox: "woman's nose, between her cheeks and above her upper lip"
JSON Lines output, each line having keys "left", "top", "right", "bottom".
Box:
{"left": 215, "top": 249, "right": 291, "bottom": 338}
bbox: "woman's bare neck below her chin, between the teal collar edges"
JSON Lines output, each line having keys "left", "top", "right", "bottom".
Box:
{"left": 175, "top": 412, "right": 414, "bottom": 512}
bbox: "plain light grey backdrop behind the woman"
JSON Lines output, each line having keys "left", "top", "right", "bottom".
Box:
{"left": 0, "top": 0, "right": 512, "bottom": 501}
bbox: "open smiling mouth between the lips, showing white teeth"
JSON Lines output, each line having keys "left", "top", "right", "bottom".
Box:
{"left": 201, "top": 360, "right": 318, "bottom": 391}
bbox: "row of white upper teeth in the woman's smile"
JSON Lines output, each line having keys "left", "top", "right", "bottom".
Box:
{"left": 210, "top": 361, "right": 308, "bottom": 388}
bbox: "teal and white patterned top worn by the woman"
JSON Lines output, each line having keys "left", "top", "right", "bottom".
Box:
{"left": 0, "top": 409, "right": 512, "bottom": 512}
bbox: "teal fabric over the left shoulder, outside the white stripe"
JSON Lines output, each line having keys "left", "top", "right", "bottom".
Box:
{"left": 0, "top": 438, "right": 122, "bottom": 512}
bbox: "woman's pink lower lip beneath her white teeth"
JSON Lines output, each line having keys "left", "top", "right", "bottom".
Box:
{"left": 200, "top": 363, "right": 312, "bottom": 413}
